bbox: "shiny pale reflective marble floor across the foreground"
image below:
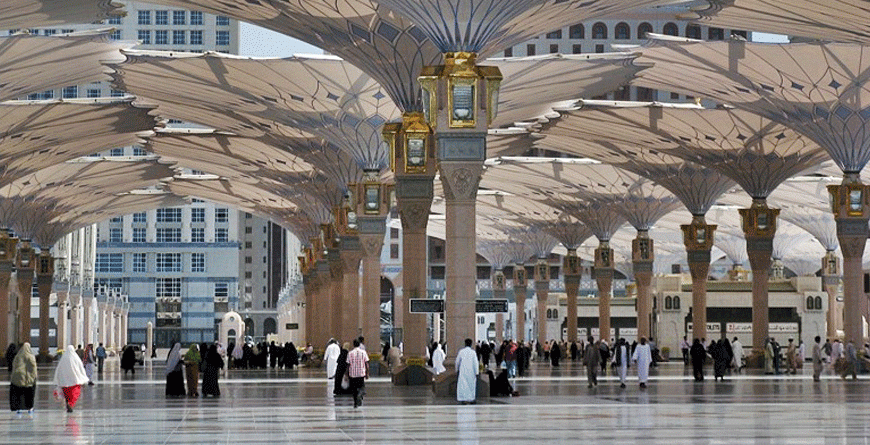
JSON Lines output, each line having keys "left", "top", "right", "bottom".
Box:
{"left": 0, "top": 359, "right": 870, "bottom": 444}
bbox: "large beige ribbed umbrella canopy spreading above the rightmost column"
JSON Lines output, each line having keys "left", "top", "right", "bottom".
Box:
{"left": 635, "top": 36, "right": 870, "bottom": 173}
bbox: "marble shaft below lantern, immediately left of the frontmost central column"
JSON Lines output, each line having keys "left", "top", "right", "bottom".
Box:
{"left": 396, "top": 175, "right": 434, "bottom": 363}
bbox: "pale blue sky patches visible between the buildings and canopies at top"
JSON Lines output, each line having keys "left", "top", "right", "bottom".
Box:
{"left": 239, "top": 22, "right": 788, "bottom": 57}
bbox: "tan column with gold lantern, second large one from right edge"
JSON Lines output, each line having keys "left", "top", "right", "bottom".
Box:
{"left": 740, "top": 198, "right": 779, "bottom": 349}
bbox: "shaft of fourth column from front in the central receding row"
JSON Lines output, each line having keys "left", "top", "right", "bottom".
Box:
{"left": 335, "top": 236, "right": 363, "bottom": 343}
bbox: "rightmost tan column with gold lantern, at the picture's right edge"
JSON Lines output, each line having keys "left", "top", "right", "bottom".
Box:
{"left": 828, "top": 179, "right": 870, "bottom": 346}
